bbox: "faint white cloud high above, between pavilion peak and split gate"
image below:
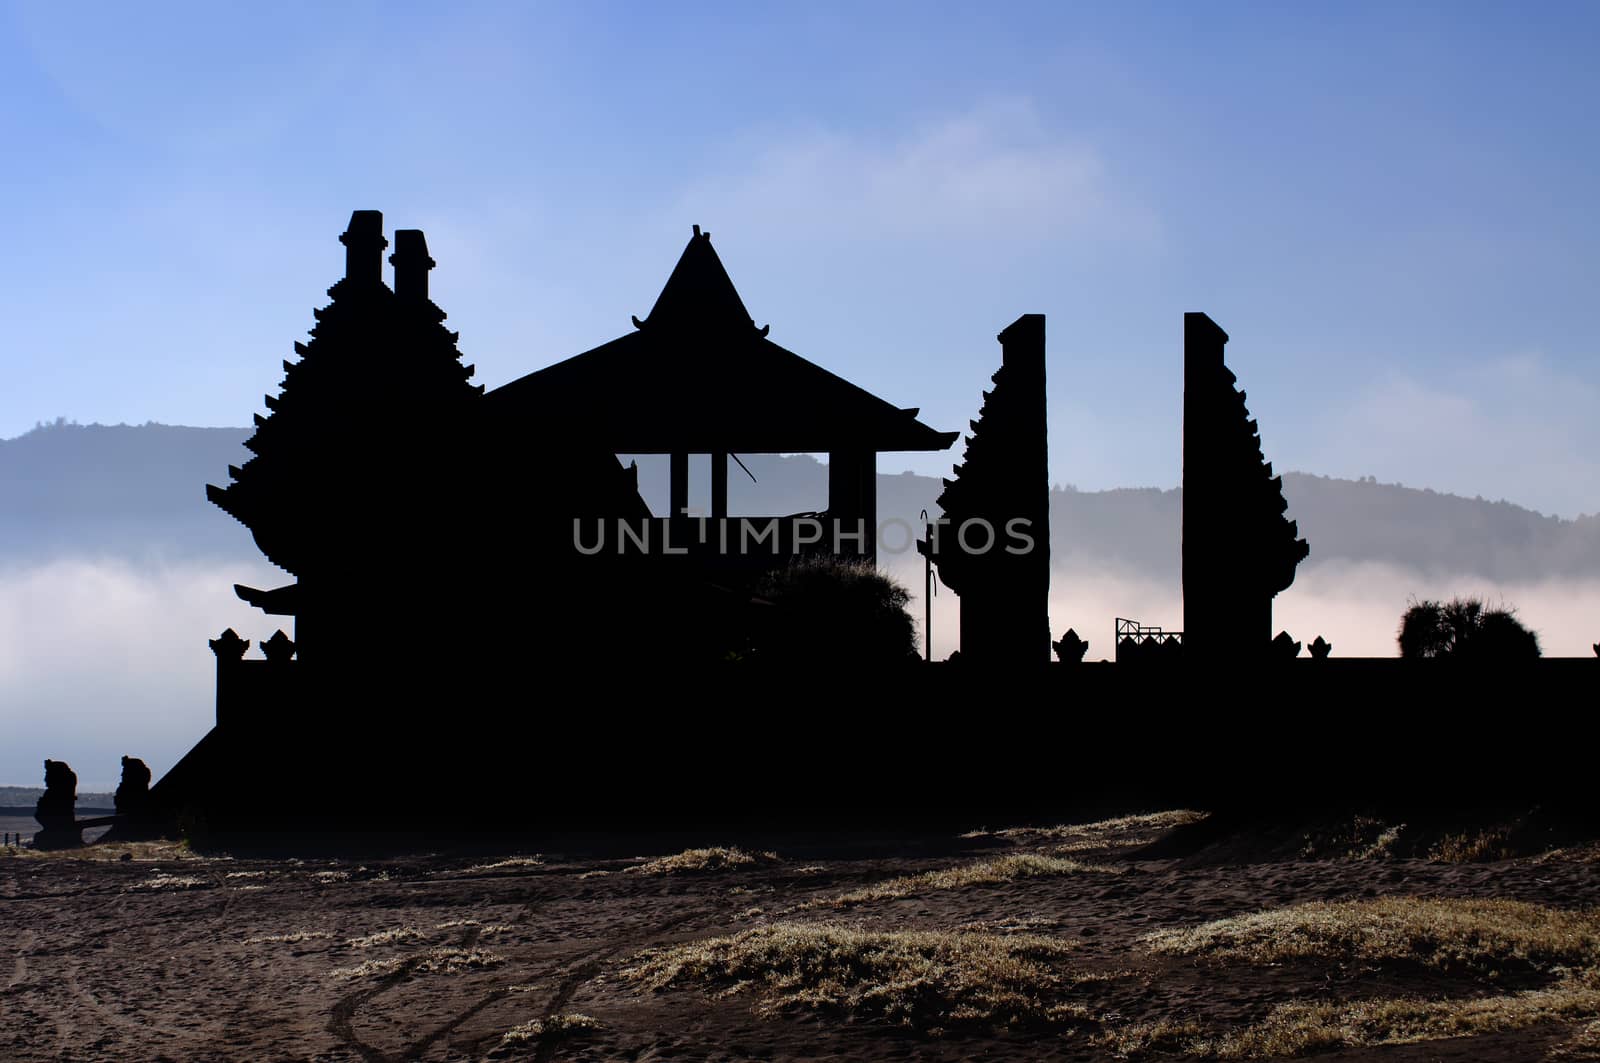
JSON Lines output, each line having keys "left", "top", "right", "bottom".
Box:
{"left": 674, "top": 101, "right": 1155, "bottom": 245}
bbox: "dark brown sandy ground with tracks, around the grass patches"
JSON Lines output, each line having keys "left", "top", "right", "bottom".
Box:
{"left": 0, "top": 821, "right": 1600, "bottom": 1061}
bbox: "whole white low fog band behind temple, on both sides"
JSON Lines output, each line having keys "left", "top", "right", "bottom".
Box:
{"left": 0, "top": 554, "right": 1600, "bottom": 791}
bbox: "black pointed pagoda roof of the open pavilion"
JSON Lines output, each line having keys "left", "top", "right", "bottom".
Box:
{"left": 485, "top": 226, "right": 960, "bottom": 453}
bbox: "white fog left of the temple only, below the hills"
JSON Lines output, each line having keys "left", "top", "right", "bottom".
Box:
{"left": 0, "top": 560, "right": 281, "bottom": 789}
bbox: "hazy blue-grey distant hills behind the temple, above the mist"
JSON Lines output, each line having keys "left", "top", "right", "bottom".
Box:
{"left": 9, "top": 423, "right": 1600, "bottom": 581}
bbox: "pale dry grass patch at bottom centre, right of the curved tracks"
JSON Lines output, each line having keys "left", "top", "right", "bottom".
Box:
{"left": 622, "top": 922, "right": 1088, "bottom": 1034}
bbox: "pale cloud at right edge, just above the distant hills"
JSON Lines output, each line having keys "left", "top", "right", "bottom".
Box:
{"left": 1294, "top": 354, "right": 1600, "bottom": 517}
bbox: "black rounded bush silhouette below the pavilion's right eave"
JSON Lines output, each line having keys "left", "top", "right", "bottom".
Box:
{"left": 754, "top": 557, "right": 922, "bottom": 664}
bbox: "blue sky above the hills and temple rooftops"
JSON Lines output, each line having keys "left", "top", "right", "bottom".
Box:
{"left": 0, "top": 3, "right": 1600, "bottom": 515}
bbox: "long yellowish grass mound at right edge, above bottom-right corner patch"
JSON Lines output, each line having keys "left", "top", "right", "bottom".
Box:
{"left": 1142, "top": 897, "right": 1600, "bottom": 973}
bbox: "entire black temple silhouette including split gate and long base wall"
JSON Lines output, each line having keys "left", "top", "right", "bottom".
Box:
{"left": 37, "top": 204, "right": 1589, "bottom": 845}
